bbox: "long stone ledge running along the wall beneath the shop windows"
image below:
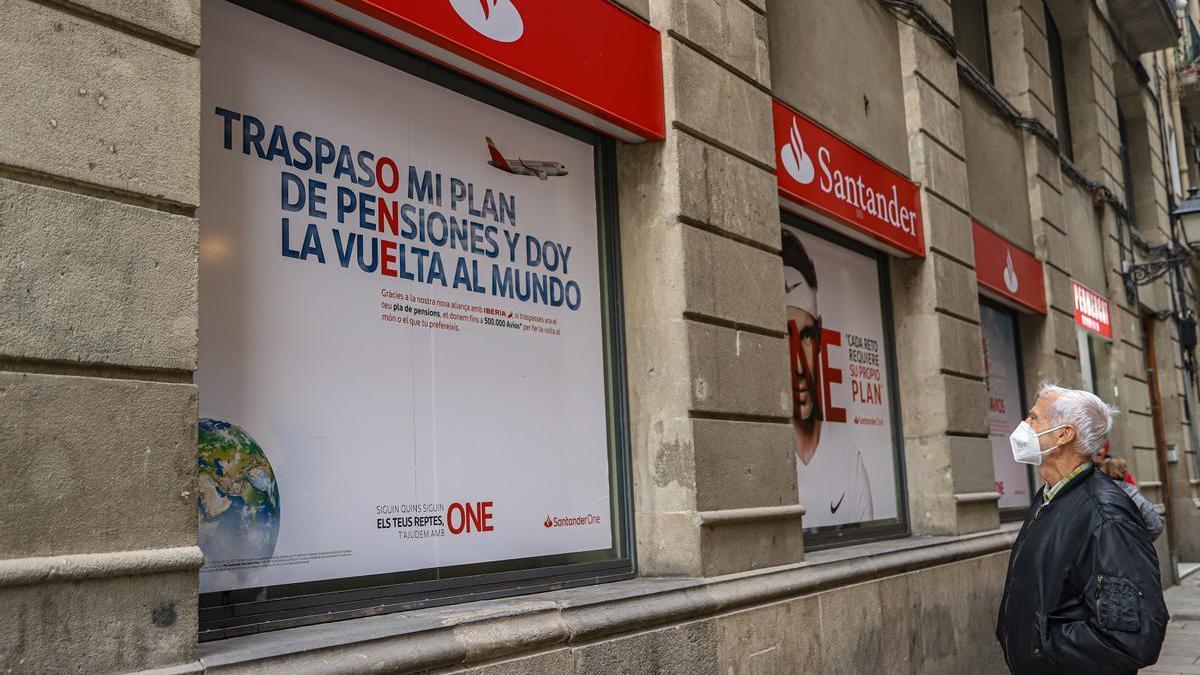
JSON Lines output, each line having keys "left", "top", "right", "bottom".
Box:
{"left": 199, "top": 526, "right": 1018, "bottom": 673}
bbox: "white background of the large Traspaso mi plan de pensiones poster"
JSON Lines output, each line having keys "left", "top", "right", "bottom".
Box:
{"left": 197, "top": 1, "right": 612, "bottom": 592}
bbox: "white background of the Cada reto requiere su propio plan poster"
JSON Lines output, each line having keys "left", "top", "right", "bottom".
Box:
{"left": 784, "top": 225, "right": 899, "bottom": 527}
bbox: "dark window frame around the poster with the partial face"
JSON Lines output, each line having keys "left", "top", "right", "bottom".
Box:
{"left": 780, "top": 209, "right": 912, "bottom": 551}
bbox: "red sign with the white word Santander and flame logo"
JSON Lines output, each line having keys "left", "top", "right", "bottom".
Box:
{"left": 775, "top": 101, "right": 925, "bottom": 258}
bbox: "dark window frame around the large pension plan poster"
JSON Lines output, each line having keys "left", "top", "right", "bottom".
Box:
{"left": 199, "top": 0, "right": 636, "bottom": 641}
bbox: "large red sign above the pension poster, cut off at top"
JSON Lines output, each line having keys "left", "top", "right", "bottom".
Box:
{"left": 300, "top": 0, "right": 666, "bottom": 141}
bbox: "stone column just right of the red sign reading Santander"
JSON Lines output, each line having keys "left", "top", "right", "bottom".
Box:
{"left": 892, "top": 0, "right": 1000, "bottom": 534}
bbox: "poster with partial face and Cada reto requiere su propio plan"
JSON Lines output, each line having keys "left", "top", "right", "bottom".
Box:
{"left": 782, "top": 225, "right": 899, "bottom": 528}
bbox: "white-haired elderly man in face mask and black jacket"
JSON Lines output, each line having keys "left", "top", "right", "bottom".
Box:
{"left": 996, "top": 384, "right": 1168, "bottom": 675}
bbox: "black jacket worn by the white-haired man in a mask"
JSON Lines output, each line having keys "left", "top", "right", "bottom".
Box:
{"left": 996, "top": 466, "right": 1169, "bottom": 675}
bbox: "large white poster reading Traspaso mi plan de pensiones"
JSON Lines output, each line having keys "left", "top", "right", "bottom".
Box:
{"left": 197, "top": 1, "right": 613, "bottom": 592}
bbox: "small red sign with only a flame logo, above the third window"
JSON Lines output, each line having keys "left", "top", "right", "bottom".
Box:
{"left": 971, "top": 220, "right": 1046, "bottom": 313}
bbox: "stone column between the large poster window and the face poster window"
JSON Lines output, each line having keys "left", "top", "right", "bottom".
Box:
{"left": 618, "top": 0, "right": 803, "bottom": 575}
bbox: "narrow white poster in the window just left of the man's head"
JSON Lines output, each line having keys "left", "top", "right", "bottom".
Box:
{"left": 979, "top": 305, "right": 1031, "bottom": 508}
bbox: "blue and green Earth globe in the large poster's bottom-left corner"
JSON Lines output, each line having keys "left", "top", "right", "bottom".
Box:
{"left": 197, "top": 419, "right": 280, "bottom": 569}
